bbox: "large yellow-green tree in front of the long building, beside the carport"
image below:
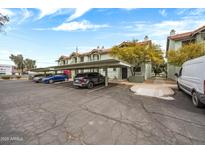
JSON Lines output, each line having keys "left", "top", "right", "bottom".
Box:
{"left": 110, "top": 42, "right": 164, "bottom": 76}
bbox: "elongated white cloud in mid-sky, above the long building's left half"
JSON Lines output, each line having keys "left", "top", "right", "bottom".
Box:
{"left": 52, "top": 20, "right": 109, "bottom": 31}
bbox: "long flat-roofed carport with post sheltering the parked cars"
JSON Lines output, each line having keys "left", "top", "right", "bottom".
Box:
{"left": 31, "top": 59, "right": 130, "bottom": 86}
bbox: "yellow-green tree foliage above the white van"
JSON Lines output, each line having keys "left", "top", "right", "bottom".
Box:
{"left": 168, "top": 43, "right": 205, "bottom": 66}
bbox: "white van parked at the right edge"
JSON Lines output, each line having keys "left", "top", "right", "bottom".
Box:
{"left": 175, "top": 56, "right": 205, "bottom": 107}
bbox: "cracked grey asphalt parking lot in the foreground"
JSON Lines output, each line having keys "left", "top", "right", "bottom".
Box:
{"left": 0, "top": 80, "right": 205, "bottom": 144}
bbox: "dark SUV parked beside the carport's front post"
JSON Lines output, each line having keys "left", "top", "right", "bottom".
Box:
{"left": 73, "top": 72, "right": 105, "bottom": 89}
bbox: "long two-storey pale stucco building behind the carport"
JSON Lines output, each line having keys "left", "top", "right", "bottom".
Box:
{"left": 58, "top": 41, "right": 152, "bottom": 80}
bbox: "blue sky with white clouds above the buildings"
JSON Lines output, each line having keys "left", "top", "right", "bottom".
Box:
{"left": 0, "top": 8, "right": 205, "bottom": 67}
